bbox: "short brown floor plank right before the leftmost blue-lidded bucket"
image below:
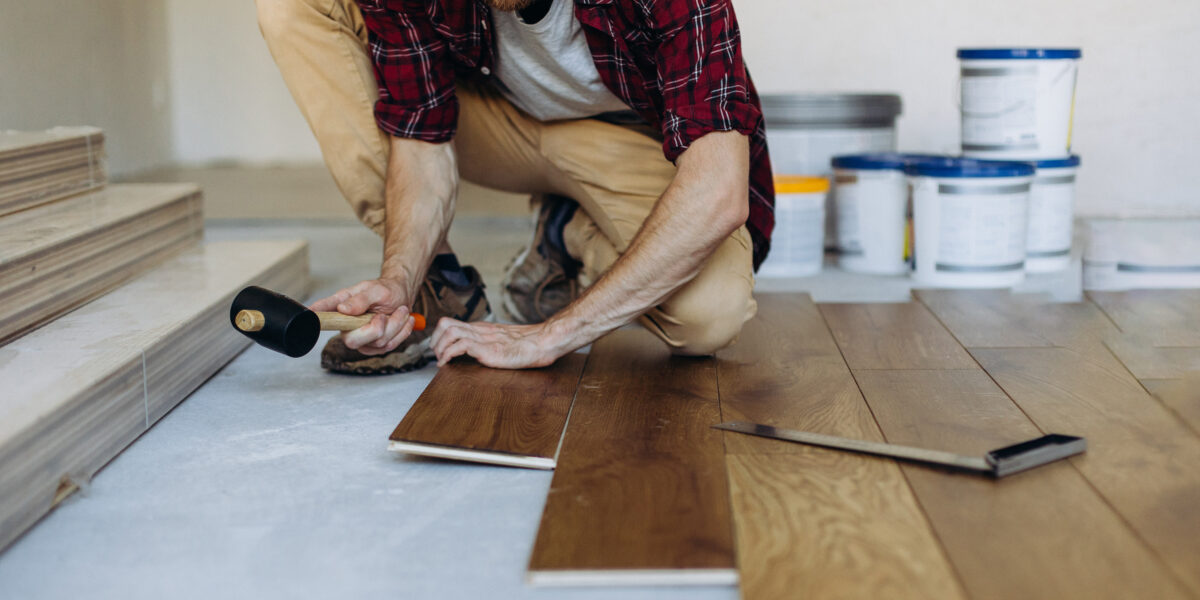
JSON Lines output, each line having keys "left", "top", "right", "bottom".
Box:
{"left": 818, "top": 302, "right": 978, "bottom": 370}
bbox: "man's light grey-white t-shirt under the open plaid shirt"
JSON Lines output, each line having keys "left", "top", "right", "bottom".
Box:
{"left": 492, "top": 0, "right": 629, "bottom": 121}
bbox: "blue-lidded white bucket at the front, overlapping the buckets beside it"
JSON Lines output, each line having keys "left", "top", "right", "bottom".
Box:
{"left": 905, "top": 158, "right": 1034, "bottom": 288}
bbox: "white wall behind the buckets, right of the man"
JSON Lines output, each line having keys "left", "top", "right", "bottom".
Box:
{"left": 734, "top": 0, "right": 1200, "bottom": 215}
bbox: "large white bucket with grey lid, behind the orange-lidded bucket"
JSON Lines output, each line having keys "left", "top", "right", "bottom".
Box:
{"left": 761, "top": 94, "right": 902, "bottom": 248}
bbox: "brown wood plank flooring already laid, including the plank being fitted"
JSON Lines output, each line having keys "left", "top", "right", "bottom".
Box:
{"left": 392, "top": 290, "right": 1200, "bottom": 599}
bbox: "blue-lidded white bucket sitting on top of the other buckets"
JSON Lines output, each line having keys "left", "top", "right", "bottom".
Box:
{"left": 959, "top": 48, "right": 1082, "bottom": 160}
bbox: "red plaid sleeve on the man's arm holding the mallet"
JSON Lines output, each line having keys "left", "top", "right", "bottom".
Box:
{"left": 358, "top": 0, "right": 458, "bottom": 143}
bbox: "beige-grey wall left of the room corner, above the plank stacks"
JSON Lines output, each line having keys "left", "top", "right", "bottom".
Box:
{"left": 0, "top": 0, "right": 172, "bottom": 175}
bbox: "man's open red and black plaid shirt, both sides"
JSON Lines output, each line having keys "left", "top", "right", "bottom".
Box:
{"left": 358, "top": 0, "right": 775, "bottom": 268}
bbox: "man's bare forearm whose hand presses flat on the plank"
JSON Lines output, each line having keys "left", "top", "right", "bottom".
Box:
{"left": 546, "top": 132, "right": 750, "bottom": 347}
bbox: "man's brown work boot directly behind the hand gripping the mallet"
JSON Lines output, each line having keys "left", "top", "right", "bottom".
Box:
{"left": 320, "top": 266, "right": 492, "bottom": 374}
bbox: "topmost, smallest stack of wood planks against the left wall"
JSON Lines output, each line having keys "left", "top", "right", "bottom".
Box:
{"left": 0, "top": 127, "right": 108, "bottom": 216}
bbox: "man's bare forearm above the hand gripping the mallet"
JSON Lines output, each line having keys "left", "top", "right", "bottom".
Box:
{"left": 380, "top": 133, "right": 458, "bottom": 298}
